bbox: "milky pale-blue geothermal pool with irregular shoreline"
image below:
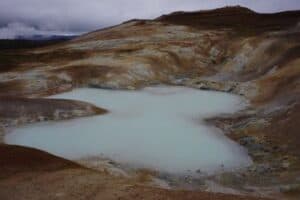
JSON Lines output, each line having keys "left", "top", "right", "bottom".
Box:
{"left": 5, "top": 86, "right": 251, "bottom": 174}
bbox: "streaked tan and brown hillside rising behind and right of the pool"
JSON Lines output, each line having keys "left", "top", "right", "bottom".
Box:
{"left": 0, "top": 7, "right": 300, "bottom": 199}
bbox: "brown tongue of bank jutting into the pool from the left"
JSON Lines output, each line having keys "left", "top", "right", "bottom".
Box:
{"left": 0, "top": 97, "right": 107, "bottom": 128}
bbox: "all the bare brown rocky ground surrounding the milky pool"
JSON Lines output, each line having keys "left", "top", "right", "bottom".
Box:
{"left": 0, "top": 7, "right": 300, "bottom": 200}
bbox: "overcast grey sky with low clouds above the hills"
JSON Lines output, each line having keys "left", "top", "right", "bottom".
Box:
{"left": 0, "top": 0, "right": 300, "bottom": 38}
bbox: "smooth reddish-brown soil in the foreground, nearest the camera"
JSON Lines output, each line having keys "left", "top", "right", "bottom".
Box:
{"left": 0, "top": 145, "right": 270, "bottom": 200}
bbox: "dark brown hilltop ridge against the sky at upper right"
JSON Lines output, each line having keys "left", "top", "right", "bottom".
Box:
{"left": 156, "top": 6, "right": 300, "bottom": 35}
